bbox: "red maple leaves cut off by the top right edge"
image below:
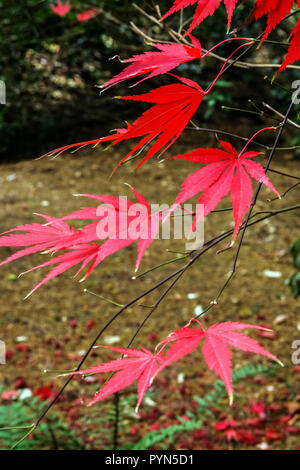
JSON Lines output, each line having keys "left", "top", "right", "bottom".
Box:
{"left": 162, "top": 0, "right": 300, "bottom": 73}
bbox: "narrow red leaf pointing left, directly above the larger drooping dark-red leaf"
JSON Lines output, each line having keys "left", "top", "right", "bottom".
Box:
{"left": 102, "top": 36, "right": 201, "bottom": 89}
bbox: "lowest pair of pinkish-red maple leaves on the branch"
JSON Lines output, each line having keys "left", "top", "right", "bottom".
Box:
{"left": 66, "top": 319, "right": 281, "bottom": 409}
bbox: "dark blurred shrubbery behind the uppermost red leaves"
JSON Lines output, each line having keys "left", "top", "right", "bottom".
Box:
{"left": 0, "top": 0, "right": 299, "bottom": 161}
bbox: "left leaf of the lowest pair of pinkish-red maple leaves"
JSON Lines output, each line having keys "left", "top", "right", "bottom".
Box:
{"left": 65, "top": 346, "right": 164, "bottom": 410}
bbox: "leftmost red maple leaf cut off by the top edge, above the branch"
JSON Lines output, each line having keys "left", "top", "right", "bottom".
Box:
{"left": 162, "top": 0, "right": 238, "bottom": 35}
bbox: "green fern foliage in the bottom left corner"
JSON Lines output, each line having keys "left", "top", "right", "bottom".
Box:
{"left": 0, "top": 397, "right": 84, "bottom": 450}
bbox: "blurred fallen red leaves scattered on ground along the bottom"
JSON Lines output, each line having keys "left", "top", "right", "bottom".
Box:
{"left": 0, "top": 358, "right": 300, "bottom": 450}
